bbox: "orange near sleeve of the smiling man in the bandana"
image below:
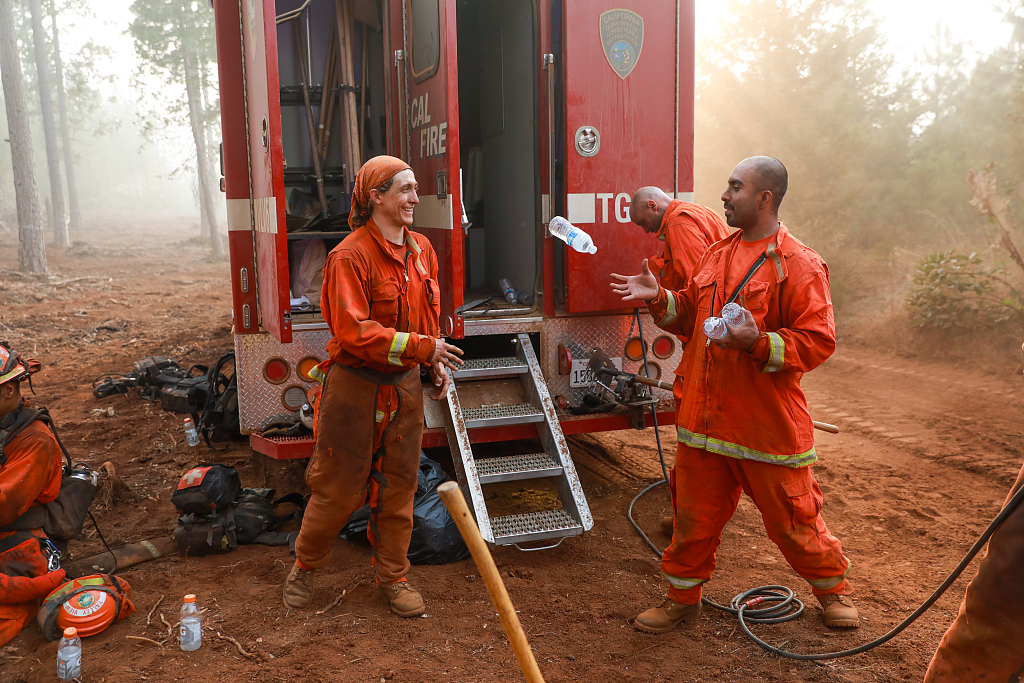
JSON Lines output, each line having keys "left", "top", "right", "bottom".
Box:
{"left": 324, "top": 255, "right": 437, "bottom": 367}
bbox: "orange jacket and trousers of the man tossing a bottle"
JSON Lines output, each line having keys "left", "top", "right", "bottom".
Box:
{"left": 649, "top": 225, "right": 852, "bottom": 604}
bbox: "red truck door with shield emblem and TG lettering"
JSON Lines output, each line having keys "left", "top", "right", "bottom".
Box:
{"left": 562, "top": 0, "right": 686, "bottom": 313}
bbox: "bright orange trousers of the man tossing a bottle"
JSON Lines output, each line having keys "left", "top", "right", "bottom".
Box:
{"left": 662, "top": 443, "right": 853, "bottom": 604}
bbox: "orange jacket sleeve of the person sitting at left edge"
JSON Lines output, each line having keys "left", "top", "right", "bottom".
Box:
{"left": 0, "top": 423, "right": 62, "bottom": 526}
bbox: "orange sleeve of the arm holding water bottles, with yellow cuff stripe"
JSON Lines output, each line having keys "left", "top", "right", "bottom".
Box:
{"left": 748, "top": 265, "right": 836, "bottom": 373}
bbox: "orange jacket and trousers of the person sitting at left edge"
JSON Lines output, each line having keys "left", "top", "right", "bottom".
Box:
{"left": 0, "top": 411, "right": 65, "bottom": 646}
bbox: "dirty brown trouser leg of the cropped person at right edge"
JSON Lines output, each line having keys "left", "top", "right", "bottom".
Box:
{"left": 925, "top": 468, "right": 1024, "bottom": 683}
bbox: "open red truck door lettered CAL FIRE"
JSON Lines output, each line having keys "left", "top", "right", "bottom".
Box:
{"left": 387, "top": 0, "right": 465, "bottom": 338}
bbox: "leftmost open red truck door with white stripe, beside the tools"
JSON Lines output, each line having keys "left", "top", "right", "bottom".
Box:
{"left": 239, "top": 0, "right": 292, "bottom": 343}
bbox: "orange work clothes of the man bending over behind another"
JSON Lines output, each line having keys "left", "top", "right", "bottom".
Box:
{"left": 649, "top": 200, "right": 731, "bottom": 408}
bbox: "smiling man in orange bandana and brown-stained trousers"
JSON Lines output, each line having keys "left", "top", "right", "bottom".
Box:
{"left": 284, "top": 157, "right": 462, "bottom": 616}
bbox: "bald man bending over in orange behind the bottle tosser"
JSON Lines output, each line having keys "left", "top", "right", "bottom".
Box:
{"left": 630, "top": 185, "right": 731, "bottom": 533}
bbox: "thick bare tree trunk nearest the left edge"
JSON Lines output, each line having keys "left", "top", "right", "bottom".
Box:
{"left": 0, "top": 1, "right": 46, "bottom": 272}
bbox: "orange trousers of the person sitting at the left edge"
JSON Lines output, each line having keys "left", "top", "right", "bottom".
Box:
{"left": 0, "top": 529, "right": 65, "bottom": 647}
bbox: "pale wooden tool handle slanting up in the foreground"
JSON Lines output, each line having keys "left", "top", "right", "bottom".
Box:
{"left": 437, "top": 481, "right": 544, "bottom": 683}
